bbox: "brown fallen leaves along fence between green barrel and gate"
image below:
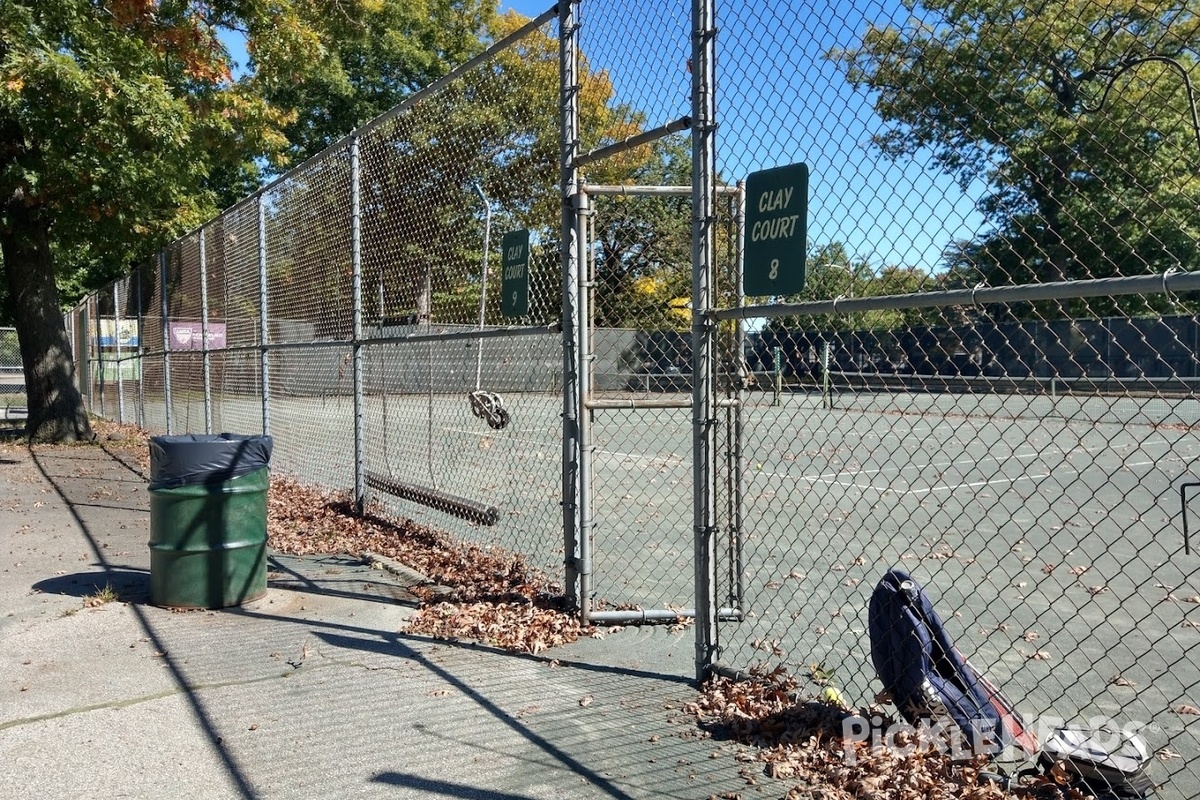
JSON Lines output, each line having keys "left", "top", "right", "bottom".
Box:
{"left": 266, "top": 476, "right": 589, "bottom": 652}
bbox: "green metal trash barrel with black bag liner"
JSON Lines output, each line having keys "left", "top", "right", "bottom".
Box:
{"left": 150, "top": 433, "right": 272, "bottom": 608}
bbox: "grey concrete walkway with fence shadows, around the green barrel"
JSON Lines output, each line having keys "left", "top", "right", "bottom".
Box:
{"left": 0, "top": 443, "right": 787, "bottom": 800}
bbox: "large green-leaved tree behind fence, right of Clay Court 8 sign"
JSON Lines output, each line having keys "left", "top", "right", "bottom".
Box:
{"left": 829, "top": 0, "right": 1200, "bottom": 293}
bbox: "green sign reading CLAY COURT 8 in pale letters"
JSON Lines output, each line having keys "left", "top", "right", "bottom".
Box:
{"left": 743, "top": 164, "right": 809, "bottom": 296}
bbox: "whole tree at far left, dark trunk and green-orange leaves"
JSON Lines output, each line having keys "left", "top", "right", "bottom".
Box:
{"left": 0, "top": 0, "right": 318, "bottom": 441}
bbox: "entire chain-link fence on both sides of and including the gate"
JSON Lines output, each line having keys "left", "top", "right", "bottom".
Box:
{"left": 73, "top": 0, "right": 1200, "bottom": 796}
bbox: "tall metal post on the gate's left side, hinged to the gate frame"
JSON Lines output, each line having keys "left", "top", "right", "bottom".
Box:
{"left": 558, "top": 0, "right": 584, "bottom": 608}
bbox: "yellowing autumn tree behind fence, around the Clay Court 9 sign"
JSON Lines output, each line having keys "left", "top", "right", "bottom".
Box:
{"left": 259, "top": 12, "right": 652, "bottom": 335}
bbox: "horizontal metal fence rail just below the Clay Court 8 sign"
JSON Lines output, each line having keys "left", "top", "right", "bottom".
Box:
{"left": 707, "top": 270, "right": 1200, "bottom": 320}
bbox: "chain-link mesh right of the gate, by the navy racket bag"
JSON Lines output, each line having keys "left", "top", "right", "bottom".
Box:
{"left": 716, "top": 2, "right": 1200, "bottom": 796}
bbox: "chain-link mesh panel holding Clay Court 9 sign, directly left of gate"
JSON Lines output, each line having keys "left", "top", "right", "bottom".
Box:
{"left": 352, "top": 16, "right": 563, "bottom": 581}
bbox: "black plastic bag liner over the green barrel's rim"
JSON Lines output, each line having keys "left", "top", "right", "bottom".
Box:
{"left": 150, "top": 433, "right": 274, "bottom": 489}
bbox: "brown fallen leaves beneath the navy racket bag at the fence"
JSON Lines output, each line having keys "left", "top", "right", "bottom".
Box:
{"left": 684, "top": 668, "right": 1082, "bottom": 800}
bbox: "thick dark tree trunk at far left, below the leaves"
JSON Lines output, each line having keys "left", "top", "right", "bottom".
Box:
{"left": 0, "top": 200, "right": 95, "bottom": 441}
